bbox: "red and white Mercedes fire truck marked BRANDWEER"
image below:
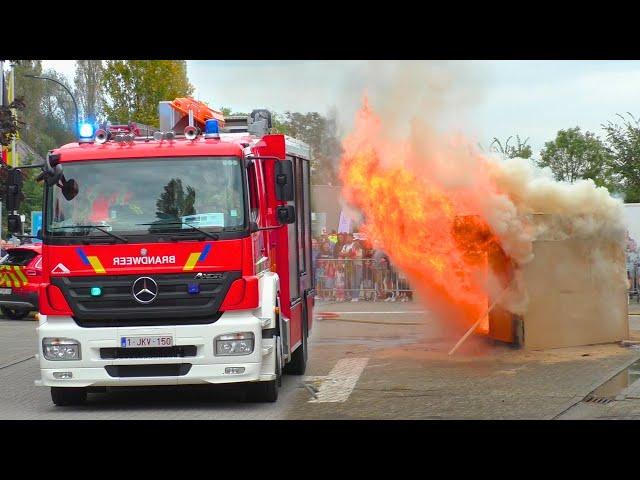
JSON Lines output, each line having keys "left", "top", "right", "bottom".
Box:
{"left": 8, "top": 98, "right": 315, "bottom": 405}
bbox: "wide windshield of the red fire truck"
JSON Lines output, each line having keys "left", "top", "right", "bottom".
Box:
{"left": 46, "top": 157, "right": 244, "bottom": 236}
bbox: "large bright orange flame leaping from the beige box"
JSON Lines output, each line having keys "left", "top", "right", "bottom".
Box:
{"left": 340, "top": 99, "right": 499, "bottom": 331}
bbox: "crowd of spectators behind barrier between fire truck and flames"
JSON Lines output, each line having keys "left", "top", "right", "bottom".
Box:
{"left": 312, "top": 230, "right": 412, "bottom": 302}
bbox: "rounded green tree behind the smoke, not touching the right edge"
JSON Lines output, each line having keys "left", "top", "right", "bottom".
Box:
{"left": 537, "top": 127, "right": 612, "bottom": 188}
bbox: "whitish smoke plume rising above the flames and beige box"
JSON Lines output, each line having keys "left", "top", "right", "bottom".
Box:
{"left": 343, "top": 62, "right": 626, "bottom": 320}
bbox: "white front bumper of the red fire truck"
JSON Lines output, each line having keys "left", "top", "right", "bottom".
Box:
{"left": 36, "top": 311, "right": 276, "bottom": 387}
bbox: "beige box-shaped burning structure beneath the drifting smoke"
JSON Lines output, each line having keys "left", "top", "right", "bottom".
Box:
{"left": 489, "top": 215, "right": 629, "bottom": 349}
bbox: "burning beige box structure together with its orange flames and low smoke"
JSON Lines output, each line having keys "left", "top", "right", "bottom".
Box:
{"left": 340, "top": 100, "right": 628, "bottom": 348}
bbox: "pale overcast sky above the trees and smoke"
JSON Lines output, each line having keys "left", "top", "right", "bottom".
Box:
{"left": 38, "top": 60, "right": 640, "bottom": 155}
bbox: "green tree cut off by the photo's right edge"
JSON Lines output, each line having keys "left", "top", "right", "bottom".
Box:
{"left": 602, "top": 113, "right": 640, "bottom": 203}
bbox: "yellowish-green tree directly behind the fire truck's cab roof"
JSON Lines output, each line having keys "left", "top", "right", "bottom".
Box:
{"left": 101, "top": 60, "right": 193, "bottom": 126}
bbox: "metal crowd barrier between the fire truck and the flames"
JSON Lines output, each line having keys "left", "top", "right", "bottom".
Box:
{"left": 315, "top": 257, "right": 413, "bottom": 302}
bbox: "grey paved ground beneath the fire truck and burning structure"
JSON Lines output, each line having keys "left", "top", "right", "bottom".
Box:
{"left": 0, "top": 302, "right": 640, "bottom": 419}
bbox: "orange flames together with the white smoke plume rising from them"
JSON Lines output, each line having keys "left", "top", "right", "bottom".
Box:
{"left": 340, "top": 62, "right": 626, "bottom": 325}
